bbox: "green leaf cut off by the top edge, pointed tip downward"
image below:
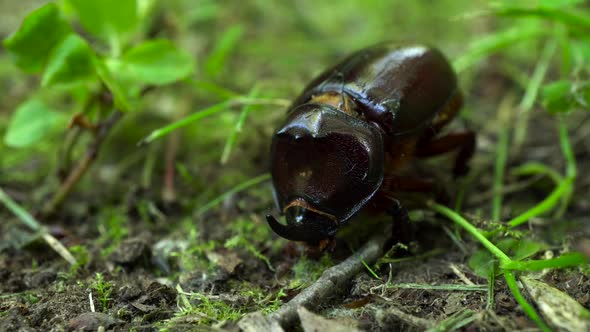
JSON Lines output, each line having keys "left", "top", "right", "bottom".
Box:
{"left": 67, "top": 0, "right": 138, "bottom": 49}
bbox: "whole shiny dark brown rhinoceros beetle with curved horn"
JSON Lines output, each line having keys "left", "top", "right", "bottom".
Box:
{"left": 266, "top": 43, "right": 475, "bottom": 246}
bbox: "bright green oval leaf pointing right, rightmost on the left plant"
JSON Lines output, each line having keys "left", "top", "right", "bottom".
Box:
{"left": 107, "top": 40, "right": 194, "bottom": 85}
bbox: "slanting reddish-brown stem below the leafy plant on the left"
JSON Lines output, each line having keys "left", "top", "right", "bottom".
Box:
{"left": 41, "top": 110, "right": 123, "bottom": 216}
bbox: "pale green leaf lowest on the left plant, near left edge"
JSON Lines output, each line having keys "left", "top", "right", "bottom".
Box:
{"left": 4, "top": 99, "right": 66, "bottom": 148}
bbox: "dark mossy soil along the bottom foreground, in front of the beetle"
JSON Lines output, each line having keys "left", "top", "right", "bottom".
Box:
{"left": 0, "top": 172, "right": 590, "bottom": 331}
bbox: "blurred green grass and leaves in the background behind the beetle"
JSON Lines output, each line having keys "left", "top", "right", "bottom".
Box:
{"left": 0, "top": 0, "right": 590, "bottom": 330}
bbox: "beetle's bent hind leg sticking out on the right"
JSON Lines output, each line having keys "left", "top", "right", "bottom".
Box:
{"left": 416, "top": 131, "right": 476, "bottom": 176}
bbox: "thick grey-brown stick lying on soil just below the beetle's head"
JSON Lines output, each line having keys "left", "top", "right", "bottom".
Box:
{"left": 269, "top": 230, "right": 391, "bottom": 328}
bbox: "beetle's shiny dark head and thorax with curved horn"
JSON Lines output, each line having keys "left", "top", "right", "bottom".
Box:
{"left": 267, "top": 103, "right": 384, "bottom": 243}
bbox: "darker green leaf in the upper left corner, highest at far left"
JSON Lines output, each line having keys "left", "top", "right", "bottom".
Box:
{"left": 4, "top": 3, "right": 72, "bottom": 72}
